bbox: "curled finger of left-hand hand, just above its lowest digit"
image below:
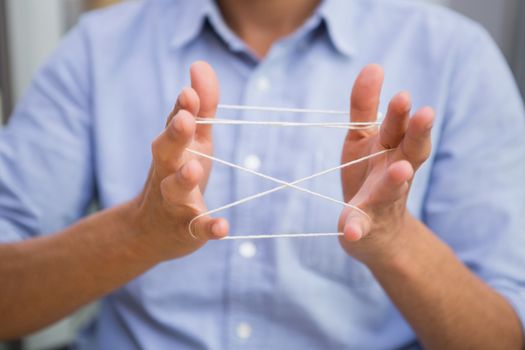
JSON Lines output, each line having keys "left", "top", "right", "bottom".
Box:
{"left": 160, "top": 159, "right": 204, "bottom": 204}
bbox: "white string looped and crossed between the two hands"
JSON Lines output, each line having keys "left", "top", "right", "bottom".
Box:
{"left": 186, "top": 105, "right": 391, "bottom": 240}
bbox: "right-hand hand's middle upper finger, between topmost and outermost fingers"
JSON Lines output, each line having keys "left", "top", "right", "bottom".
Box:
{"left": 379, "top": 92, "right": 411, "bottom": 149}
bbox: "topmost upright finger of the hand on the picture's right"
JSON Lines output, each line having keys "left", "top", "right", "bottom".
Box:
{"left": 348, "top": 64, "right": 384, "bottom": 137}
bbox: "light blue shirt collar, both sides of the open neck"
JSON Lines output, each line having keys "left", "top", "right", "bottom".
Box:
{"left": 171, "top": 0, "right": 355, "bottom": 56}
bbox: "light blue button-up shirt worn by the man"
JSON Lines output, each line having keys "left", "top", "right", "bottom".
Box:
{"left": 0, "top": 0, "right": 525, "bottom": 349}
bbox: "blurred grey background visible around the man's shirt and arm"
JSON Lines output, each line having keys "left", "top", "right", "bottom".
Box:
{"left": 0, "top": 0, "right": 525, "bottom": 350}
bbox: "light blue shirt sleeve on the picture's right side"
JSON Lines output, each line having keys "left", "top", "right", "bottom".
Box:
{"left": 423, "top": 23, "right": 525, "bottom": 330}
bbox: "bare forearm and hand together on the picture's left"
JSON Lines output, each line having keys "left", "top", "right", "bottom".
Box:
{"left": 0, "top": 62, "right": 228, "bottom": 340}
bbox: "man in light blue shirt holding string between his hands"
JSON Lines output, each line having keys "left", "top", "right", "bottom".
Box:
{"left": 0, "top": 0, "right": 525, "bottom": 349}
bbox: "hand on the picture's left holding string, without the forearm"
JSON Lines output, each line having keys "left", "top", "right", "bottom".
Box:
{"left": 129, "top": 62, "right": 228, "bottom": 260}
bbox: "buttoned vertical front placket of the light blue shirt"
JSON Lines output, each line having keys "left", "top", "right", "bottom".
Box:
{"left": 227, "top": 64, "right": 272, "bottom": 347}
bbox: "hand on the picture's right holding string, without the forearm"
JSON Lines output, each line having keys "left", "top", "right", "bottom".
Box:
{"left": 339, "top": 65, "right": 434, "bottom": 263}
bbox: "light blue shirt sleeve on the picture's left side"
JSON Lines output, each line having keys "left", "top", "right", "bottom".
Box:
{"left": 0, "top": 23, "right": 94, "bottom": 242}
